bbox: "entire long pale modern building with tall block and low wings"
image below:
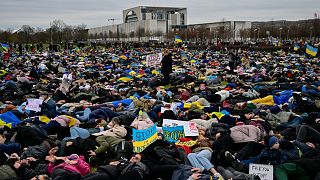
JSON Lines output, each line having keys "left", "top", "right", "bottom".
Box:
{"left": 88, "top": 6, "right": 319, "bottom": 42}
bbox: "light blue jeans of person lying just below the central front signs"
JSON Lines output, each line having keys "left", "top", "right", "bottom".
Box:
{"left": 188, "top": 150, "right": 214, "bottom": 171}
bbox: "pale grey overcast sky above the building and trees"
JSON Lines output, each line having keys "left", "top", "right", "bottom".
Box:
{"left": 0, "top": 0, "right": 320, "bottom": 29}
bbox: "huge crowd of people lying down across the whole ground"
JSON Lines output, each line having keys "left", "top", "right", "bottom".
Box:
{"left": 0, "top": 46, "right": 320, "bottom": 180}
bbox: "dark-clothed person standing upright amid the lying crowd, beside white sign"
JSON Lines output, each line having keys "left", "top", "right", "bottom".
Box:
{"left": 161, "top": 49, "right": 172, "bottom": 85}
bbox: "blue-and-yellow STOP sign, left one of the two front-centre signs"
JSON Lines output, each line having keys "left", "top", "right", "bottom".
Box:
{"left": 132, "top": 124, "right": 158, "bottom": 153}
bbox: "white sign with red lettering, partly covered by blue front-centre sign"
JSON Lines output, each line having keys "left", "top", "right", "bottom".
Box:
{"left": 162, "top": 119, "right": 199, "bottom": 136}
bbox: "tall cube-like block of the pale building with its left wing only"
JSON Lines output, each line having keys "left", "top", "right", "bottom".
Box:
{"left": 88, "top": 6, "right": 187, "bottom": 41}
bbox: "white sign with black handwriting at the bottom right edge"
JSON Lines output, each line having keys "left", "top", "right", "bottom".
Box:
{"left": 249, "top": 164, "right": 273, "bottom": 180}
